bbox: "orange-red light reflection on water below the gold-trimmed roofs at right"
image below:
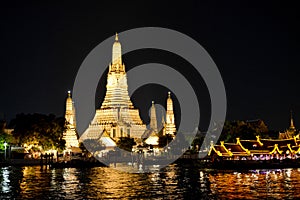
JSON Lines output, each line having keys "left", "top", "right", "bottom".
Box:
{"left": 209, "top": 169, "right": 300, "bottom": 199}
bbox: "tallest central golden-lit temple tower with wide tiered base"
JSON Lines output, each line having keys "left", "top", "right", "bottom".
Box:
{"left": 81, "top": 34, "right": 146, "bottom": 140}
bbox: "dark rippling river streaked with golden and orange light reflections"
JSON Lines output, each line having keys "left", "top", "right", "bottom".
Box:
{"left": 0, "top": 164, "right": 300, "bottom": 200}
